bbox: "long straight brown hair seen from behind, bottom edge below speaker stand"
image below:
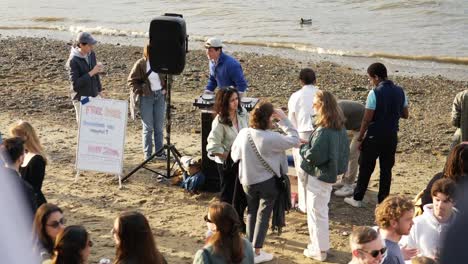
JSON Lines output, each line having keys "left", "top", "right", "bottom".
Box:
{"left": 112, "top": 211, "right": 167, "bottom": 264}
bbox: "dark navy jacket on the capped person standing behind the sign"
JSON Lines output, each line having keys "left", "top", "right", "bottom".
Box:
{"left": 67, "top": 51, "right": 102, "bottom": 100}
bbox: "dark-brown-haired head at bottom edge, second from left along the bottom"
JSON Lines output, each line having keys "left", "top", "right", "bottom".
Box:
{"left": 43, "top": 225, "right": 93, "bottom": 264}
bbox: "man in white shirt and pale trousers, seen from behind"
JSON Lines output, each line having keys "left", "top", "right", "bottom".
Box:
{"left": 288, "top": 68, "right": 318, "bottom": 213}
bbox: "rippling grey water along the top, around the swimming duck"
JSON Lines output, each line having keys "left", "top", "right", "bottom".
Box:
{"left": 0, "top": 0, "right": 468, "bottom": 64}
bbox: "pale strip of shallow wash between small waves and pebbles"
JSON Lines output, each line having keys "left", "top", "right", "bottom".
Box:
{"left": 0, "top": 29, "right": 468, "bottom": 81}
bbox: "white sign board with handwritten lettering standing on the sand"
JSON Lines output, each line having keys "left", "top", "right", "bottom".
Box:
{"left": 76, "top": 97, "right": 128, "bottom": 176}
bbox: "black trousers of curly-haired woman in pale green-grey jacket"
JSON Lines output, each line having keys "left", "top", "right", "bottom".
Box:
{"left": 216, "top": 163, "right": 247, "bottom": 231}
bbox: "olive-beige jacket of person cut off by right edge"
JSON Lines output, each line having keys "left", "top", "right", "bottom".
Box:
{"left": 452, "top": 90, "right": 468, "bottom": 141}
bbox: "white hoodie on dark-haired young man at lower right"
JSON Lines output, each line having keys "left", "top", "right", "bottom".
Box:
{"left": 408, "top": 204, "right": 458, "bottom": 258}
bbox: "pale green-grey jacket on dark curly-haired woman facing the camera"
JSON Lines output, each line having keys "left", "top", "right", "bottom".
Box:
{"left": 206, "top": 108, "right": 249, "bottom": 164}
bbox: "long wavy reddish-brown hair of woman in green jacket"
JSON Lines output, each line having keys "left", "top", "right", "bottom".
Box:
{"left": 315, "top": 90, "right": 345, "bottom": 130}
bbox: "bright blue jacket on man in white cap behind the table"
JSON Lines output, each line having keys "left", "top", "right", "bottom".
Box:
{"left": 205, "top": 52, "right": 247, "bottom": 93}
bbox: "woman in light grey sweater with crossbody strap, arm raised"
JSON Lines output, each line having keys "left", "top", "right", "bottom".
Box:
{"left": 231, "top": 102, "right": 300, "bottom": 263}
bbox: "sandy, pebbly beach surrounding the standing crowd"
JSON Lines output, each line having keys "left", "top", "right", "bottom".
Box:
{"left": 0, "top": 37, "right": 468, "bottom": 264}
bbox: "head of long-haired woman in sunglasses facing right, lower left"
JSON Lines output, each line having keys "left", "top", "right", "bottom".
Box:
{"left": 33, "top": 203, "right": 65, "bottom": 260}
